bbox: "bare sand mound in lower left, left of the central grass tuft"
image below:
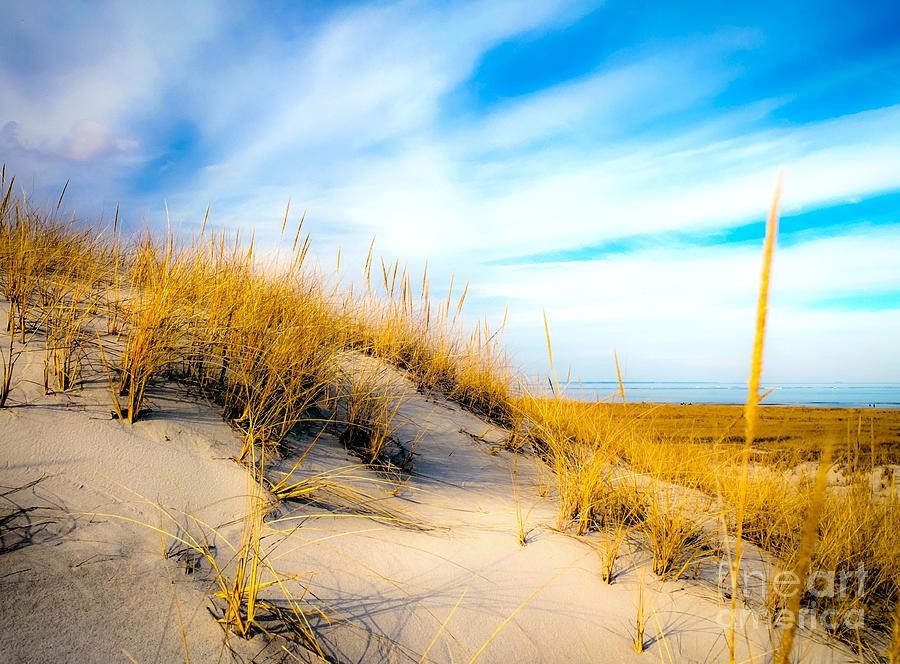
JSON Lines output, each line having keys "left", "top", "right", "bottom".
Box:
{"left": 0, "top": 350, "right": 272, "bottom": 662}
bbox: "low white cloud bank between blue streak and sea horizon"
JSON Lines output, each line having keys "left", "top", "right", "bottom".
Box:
{"left": 486, "top": 227, "right": 900, "bottom": 381}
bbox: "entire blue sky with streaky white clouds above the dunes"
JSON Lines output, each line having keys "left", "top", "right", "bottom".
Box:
{"left": 0, "top": 0, "right": 900, "bottom": 382}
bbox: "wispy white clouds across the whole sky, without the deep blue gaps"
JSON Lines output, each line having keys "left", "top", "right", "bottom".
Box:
{"left": 0, "top": 0, "right": 900, "bottom": 379}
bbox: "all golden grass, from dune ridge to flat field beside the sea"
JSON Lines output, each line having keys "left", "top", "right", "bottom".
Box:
{"left": 0, "top": 167, "right": 900, "bottom": 662}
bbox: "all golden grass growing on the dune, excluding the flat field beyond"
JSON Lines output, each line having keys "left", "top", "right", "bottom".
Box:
{"left": 0, "top": 175, "right": 900, "bottom": 658}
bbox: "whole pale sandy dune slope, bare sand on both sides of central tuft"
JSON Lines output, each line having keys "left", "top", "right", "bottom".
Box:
{"left": 0, "top": 348, "right": 845, "bottom": 663}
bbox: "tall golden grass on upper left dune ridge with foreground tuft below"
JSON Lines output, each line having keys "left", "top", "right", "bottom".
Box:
{"left": 0, "top": 179, "right": 507, "bottom": 656}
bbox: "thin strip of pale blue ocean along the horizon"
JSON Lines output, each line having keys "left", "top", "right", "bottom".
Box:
{"left": 563, "top": 381, "right": 900, "bottom": 408}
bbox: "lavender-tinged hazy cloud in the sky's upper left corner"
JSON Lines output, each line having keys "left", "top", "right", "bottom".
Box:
{"left": 0, "top": 2, "right": 229, "bottom": 189}
